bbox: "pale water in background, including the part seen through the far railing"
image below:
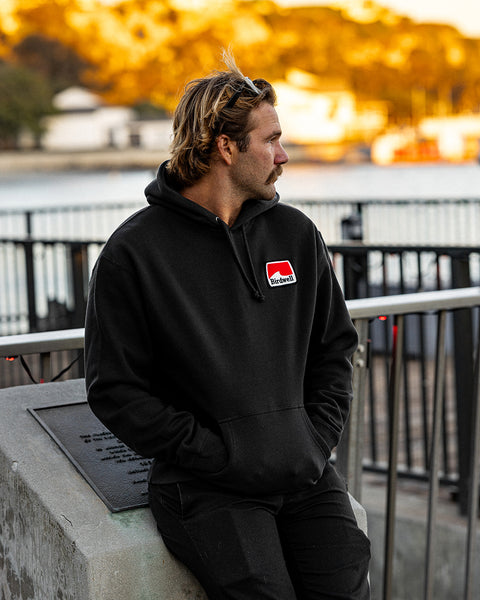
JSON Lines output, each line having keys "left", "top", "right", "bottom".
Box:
{"left": 0, "top": 163, "right": 480, "bottom": 246}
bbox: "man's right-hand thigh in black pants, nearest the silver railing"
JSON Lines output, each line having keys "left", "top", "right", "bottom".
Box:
{"left": 278, "top": 464, "right": 370, "bottom": 600}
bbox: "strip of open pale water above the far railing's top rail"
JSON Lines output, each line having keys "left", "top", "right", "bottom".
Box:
{"left": 0, "top": 163, "right": 480, "bottom": 210}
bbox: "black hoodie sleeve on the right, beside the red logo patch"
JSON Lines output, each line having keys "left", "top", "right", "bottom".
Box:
{"left": 304, "top": 234, "right": 358, "bottom": 458}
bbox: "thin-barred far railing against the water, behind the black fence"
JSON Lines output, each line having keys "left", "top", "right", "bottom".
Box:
{"left": 0, "top": 198, "right": 480, "bottom": 246}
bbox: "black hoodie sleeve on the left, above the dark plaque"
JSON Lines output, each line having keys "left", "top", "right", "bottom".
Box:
{"left": 85, "top": 255, "right": 227, "bottom": 473}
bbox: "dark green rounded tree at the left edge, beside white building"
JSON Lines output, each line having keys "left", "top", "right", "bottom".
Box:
{"left": 0, "top": 63, "right": 54, "bottom": 149}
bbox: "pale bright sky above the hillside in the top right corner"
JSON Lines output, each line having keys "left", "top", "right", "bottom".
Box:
{"left": 276, "top": 0, "right": 480, "bottom": 38}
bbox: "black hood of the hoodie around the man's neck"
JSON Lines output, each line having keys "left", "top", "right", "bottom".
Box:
{"left": 145, "top": 161, "right": 280, "bottom": 231}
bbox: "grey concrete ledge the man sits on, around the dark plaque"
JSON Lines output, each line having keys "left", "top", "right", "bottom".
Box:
{"left": 0, "top": 379, "right": 366, "bottom": 600}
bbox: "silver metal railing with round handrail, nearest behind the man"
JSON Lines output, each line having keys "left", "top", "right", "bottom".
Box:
{"left": 0, "top": 288, "right": 480, "bottom": 600}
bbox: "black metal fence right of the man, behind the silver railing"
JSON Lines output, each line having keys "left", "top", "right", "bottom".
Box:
{"left": 330, "top": 243, "right": 480, "bottom": 513}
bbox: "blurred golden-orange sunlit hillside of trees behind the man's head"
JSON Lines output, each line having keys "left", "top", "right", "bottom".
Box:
{"left": 0, "top": 0, "right": 480, "bottom": 159}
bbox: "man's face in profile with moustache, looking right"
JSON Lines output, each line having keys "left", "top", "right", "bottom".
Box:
{"left": 230, "top": 102, "right": 288, "bottom": 200}
